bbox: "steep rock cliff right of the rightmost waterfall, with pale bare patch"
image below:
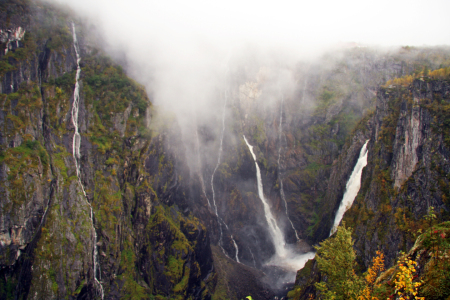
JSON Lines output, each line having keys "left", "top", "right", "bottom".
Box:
{"left": 347, "top": 76, "right": 450, "bottom": 266}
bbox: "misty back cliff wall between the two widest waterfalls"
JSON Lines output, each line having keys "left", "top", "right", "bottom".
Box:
{"left": 199, "top": 49, "right": 448, "bottom": 265}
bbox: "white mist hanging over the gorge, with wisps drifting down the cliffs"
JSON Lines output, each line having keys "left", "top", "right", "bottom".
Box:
{"left": 50, "top": 0, "right": 450, "bottom": 251}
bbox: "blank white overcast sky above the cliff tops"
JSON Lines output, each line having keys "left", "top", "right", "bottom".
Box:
{"left": 59, "top": 0, "right": 450, "bottom": 46}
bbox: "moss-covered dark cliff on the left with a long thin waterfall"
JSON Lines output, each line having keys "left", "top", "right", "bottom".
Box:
{"left": 0, "top": 1, "right": 214, "bottom": 299}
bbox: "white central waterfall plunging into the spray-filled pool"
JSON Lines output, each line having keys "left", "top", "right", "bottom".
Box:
{"left": 243, "top": 135, "right": 286, "bottom": 257}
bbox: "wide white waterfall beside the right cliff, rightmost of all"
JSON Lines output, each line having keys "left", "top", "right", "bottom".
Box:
{"left": 330, "top": 140, "right": 369, "bottom": 236}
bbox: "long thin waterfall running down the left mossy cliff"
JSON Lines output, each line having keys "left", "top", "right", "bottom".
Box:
{"left": 72, "top": 22, "right": 104, "bottom": 299}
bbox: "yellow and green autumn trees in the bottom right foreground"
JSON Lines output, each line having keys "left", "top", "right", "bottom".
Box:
{"left": 288, "top": 221, "right": 450, "bottom": 300}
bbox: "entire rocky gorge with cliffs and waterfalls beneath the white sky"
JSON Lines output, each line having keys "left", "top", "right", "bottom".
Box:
{"left": 0, "top": 0, "right": 450, "bottom": 299}
